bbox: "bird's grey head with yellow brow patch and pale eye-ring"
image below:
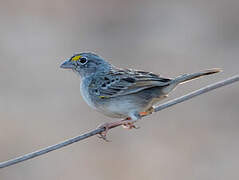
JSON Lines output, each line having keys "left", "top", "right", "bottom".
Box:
{"left": 60, "top": 53, "right": 111, "bottom": 77}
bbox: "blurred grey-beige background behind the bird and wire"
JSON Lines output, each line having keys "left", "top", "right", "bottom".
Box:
{"left": 0, "top": 0, "right": 239, "bottom": 180}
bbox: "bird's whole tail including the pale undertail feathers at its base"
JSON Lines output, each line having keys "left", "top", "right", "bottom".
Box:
{"left": 163, "top": 68, "right": 221, "bottom": 94}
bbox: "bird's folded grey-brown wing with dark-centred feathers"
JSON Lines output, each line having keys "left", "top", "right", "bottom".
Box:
{"left": 90, "top": 68, "right": 171, "bottom": 98}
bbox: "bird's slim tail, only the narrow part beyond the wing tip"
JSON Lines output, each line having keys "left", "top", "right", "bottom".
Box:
{"left": 173, "top": 68, "right": 221, "bottom": 84}
